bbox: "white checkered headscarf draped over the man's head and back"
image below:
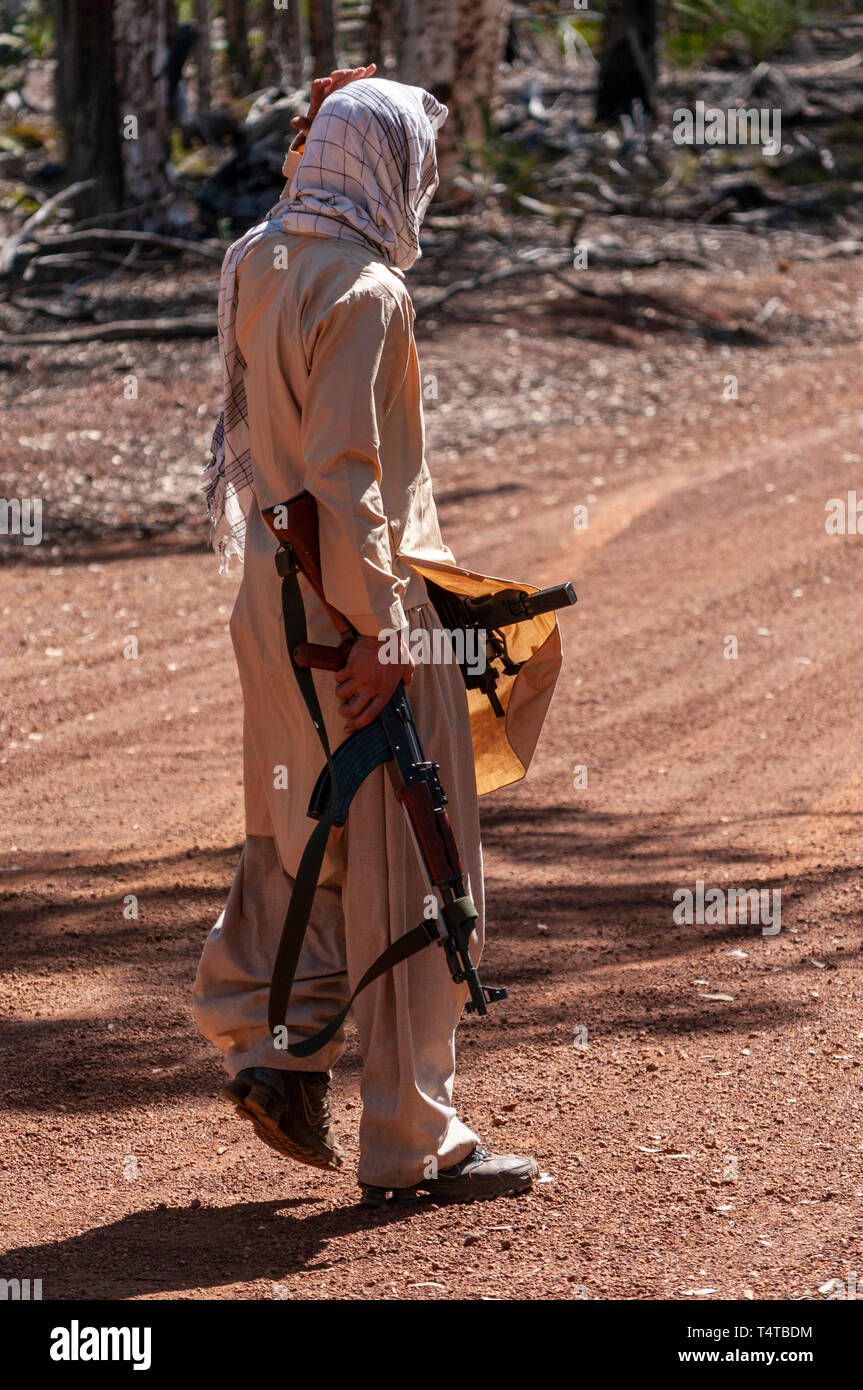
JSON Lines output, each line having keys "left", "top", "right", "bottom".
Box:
{"left": 204, "top": 78, "right": 447, "bottom": 573}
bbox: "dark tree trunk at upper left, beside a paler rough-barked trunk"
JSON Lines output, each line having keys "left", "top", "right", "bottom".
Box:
{"left": 54, "top": 0, "right": 124, "bottom": 213}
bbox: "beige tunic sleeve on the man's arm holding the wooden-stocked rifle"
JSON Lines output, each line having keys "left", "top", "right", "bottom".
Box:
{"left": 302, "top": 279, "right": 411, "bottom": 637}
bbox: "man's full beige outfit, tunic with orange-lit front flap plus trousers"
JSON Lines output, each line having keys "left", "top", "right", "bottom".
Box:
{"left": 195, "top": 143, "right": 560, "bottom": 1186}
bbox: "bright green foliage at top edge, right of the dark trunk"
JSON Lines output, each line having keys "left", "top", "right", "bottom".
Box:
{"left": 667, "top": 0, "right": 813, "bottom": 65}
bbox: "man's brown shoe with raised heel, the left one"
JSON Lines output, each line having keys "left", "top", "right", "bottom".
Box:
{"left": 222, "top": 1066, "right": 345, "bottom": 1169}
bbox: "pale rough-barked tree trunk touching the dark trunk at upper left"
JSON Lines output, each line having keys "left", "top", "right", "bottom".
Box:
{"left": 114, "top": 0, "right": 170, "bottom": 214}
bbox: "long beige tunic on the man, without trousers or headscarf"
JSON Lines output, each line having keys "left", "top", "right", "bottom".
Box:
{"left": 231, "top": 223, "right": 452, "bottom": 874}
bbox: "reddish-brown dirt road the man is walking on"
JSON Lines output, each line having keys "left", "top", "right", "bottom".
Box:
{"left": 0, "top": 255, "right": 863, "bottom": 1300}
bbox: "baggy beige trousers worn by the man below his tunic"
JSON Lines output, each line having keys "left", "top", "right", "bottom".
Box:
{"left": 195, "top": 605, "right": 484, "bottom": 1187}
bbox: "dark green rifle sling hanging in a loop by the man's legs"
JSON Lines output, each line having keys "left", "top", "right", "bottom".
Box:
{"left": 267, "top": 552, "right": 436, "bottom": 1056}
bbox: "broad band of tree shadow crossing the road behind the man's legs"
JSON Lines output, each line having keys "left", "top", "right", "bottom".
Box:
{"left": 4, "top": 806, "right": 857, "bottom": 1113}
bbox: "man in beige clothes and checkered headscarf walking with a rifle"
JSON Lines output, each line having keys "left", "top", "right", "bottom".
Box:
{"left": 195, "top": 68, "right": 538, "bottom": 1202}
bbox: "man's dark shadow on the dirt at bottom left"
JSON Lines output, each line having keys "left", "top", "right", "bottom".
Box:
{"left": 0, "top": 1197, "right": 424, "bottom": 1300}
